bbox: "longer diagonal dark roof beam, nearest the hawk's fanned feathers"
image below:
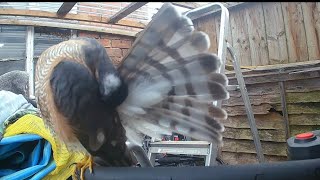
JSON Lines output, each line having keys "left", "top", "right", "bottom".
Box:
{"left": 108, "top": 2, "right": 148, "bottom": 24}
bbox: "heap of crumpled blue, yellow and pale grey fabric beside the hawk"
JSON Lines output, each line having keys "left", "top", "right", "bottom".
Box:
{"left": 0, "top": 91, "right": 85, "bottom": 180}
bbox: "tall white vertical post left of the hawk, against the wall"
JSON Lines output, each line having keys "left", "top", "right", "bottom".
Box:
{"left": 25, "top": 26, "right": 35, "bottom": 99}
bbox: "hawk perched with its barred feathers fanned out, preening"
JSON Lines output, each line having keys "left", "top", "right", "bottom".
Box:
{"left": 35, "top": 3, "right": 229, "bottom": 177}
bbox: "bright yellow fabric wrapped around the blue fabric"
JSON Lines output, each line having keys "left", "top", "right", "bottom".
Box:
{"left": 4, "top": 114, "right": 85, "bottom": 179}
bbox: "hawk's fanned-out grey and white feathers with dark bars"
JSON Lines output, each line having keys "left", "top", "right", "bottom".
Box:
{"left": 118, "top": 3, "right": 229, "bottom": 146}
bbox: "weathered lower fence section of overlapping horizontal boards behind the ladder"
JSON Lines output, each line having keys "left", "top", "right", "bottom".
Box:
{"left": 221, "top": 61, "right": 320, "bottom": 164}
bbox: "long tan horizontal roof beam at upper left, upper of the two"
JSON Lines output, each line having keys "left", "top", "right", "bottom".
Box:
{"left": 0, "top": 9, "right": 146, "bottom": 28}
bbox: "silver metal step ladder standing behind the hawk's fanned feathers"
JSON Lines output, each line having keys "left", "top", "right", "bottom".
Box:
{"left": 148, "top": 3, "right": 265, "bottom": 166}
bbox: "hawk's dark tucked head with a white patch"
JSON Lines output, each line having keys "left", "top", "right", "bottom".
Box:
{"left": 100, "top": 73, "right": 128, "bottom": 107}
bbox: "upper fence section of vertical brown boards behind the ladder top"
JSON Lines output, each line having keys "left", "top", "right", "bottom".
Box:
{"left": 194, "top": 2, "right": 320, "bottom": 66}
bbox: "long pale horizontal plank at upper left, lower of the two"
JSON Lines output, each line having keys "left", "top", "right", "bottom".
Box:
{"left": 0, "top": 19, "right": 137, "bottom": 37}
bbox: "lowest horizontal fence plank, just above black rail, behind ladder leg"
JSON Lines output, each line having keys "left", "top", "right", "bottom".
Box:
{"left": 222, "top": 152, "right": 287, "bottom": 165}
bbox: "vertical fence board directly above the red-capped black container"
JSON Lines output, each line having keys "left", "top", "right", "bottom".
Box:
{"left": 281, "top": 2, "right": 309, "bottom": 63}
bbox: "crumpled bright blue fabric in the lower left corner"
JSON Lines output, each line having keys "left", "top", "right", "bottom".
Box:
{"left": 0, "top": 134, "right": 56, "bottom": 180}
